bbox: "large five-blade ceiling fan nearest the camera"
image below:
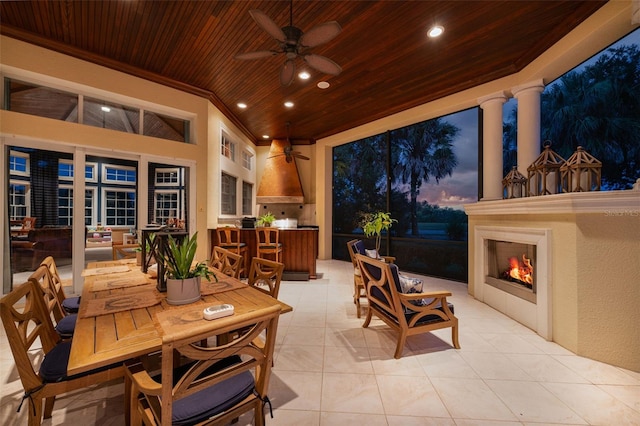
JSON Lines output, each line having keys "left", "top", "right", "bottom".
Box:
{"left": 235, "top": 0, "right": 342, "bottom": 86}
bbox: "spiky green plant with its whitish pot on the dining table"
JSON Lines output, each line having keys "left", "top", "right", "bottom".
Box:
{"left": 158, "top": 232, "right": 218, "bottom": 305}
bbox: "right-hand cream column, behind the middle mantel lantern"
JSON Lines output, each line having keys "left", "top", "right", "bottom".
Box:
{"left": 511, "top": 80, "right": 544, "bottom": 176}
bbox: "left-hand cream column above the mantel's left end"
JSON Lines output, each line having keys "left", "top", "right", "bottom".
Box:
{"left": 478, "top": 92, "right": 507, "bottom": 200}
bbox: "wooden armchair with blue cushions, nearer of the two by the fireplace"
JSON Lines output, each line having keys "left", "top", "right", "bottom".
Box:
{"left": 356, "top": 254, "right": 460, "bottom": 358}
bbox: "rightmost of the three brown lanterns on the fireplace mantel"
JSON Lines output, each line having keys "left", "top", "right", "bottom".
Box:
{"left": 560, "top": 146, "right": 602, "bottom": 192}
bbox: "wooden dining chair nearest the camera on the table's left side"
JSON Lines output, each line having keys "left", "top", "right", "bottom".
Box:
{"left": 0, "top": 281, "right": 124, "bottom": 426}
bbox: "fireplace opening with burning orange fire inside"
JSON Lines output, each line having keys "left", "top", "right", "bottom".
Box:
{"left": 485, "top": 239, "right": 537, "bottom": 303}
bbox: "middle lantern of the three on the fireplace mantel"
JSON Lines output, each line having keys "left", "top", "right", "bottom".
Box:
{"left": 527, "top": 141, "right": 565, "bottom": 195}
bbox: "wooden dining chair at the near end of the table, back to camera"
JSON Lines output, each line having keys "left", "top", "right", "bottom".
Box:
{"left": 125, "top": 305, "right": 281, "bottom": 426}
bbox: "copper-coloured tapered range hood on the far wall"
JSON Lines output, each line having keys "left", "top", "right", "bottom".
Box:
{"left": 256, "top": 139, "right": 304, "bottom": 204}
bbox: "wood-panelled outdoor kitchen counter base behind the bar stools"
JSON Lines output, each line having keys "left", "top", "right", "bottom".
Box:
{"left": 209, "top": 227, "right": 318, "bottom": 279}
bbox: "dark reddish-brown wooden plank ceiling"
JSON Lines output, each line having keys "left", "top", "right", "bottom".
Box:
{"left": 0, "top": 0, "right": 604, "bottom": 144}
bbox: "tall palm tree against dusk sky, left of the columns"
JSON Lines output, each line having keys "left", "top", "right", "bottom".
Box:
{"left": 391, "top": 118, "right": 460, "bottom": 235}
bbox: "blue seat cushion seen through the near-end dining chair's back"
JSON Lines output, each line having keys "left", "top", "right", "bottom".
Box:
{"left": 154, "top": 355, "right": 255, "bottom": 425}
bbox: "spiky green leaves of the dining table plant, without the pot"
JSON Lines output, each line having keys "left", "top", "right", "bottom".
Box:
{"left": 158, "top": 232, "right": 218, "bottom": 281}
